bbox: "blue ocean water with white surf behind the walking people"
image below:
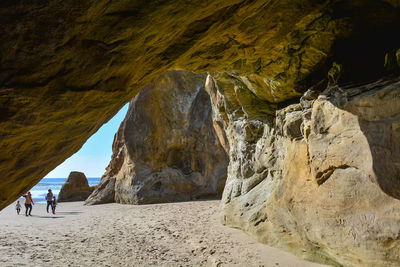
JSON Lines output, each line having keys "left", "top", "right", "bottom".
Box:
{"left": 20, "top": 177, "right": 100, "bottom": 203}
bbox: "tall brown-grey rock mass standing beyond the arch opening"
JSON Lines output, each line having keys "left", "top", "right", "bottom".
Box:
{"left": 86, "top": 71, "right": 228, "bottom": 204}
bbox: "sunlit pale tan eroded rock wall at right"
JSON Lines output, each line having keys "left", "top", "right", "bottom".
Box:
{"left": 207, "top": 77, "right": 400, "bottom": 266}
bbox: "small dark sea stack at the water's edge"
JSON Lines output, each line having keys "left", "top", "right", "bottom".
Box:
{"left": 57, "top": 172, "right": 94, "bottom": 202}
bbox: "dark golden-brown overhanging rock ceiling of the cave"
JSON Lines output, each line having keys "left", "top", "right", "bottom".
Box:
{"left": 0, "top": 0, "right": 400, "bottom": 209}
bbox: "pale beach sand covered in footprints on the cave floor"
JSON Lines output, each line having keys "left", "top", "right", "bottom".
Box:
{"left": 0, "top": 200, "right": 322, "bottom": 267}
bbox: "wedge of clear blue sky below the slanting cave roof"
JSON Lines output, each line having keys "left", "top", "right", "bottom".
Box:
{"left": 44, "top": 104, "right": 129, "bottom": 178}
